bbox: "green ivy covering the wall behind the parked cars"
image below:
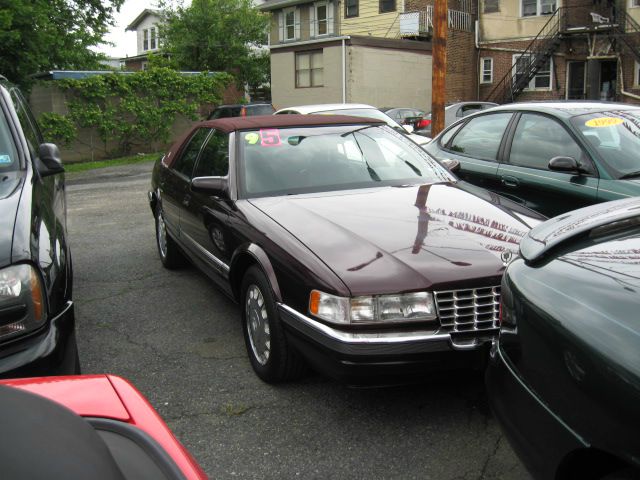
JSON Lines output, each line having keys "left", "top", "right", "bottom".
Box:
{"left": 39, "top": 66, "right": 233, "bottom": 157}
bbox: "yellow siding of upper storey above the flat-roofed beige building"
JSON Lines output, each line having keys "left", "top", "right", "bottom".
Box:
{"left": 338, "top": 0, "right": 401, "bottom": 38}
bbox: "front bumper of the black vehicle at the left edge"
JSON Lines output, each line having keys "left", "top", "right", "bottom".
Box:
{"left": 0, "top": 301, "right": 79, "bottom": 378}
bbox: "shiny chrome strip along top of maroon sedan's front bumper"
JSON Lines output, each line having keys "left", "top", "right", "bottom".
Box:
{"left": 277, "top": 303, "right": 451, "bottom": 345}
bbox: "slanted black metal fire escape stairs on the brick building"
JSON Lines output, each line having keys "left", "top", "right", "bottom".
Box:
{"left": 486, "top": 7, "right": 565, "bottom": 103}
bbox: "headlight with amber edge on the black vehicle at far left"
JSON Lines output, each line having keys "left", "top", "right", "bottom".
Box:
{"left": 0, "top": 265, "right": 46, "bottom": 340}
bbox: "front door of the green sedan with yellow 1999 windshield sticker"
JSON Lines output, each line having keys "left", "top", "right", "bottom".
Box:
{"left": 497, "top": 112, "right": 598, "bottom": 217}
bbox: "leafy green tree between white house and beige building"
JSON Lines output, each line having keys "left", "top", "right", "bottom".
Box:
{"left": 161, "top": 0, "right": 269, "bottom": 85}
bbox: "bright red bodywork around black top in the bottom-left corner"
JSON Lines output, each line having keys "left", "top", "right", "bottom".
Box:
{"left": 0, "top": 375, "right": 207, "bottom": 479}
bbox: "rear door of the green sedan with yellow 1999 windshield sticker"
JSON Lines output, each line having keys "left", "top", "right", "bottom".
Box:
{"left": 427, "top": 112, "right": 513, "bottom": 190}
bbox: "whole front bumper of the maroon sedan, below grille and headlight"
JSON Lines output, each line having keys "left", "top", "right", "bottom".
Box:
{"left": 278, "top": 304, "right": 496, "bottom": 385}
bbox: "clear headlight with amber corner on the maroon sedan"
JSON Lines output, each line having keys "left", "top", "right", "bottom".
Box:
{"left": 309, "top": 290, "right": 437, "bottom": 324}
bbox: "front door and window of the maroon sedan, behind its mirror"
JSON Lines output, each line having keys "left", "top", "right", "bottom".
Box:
{"left": 180, "top": 130, "right": 235, "bottom": 287}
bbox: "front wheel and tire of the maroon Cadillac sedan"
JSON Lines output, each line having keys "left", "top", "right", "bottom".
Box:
{"left": 241, "top": 266, "right": 306, "bottom": 383}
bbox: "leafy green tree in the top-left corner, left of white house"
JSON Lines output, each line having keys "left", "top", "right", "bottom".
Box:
{"left": 0, "top": 0, "right": 124, "bottom": 87}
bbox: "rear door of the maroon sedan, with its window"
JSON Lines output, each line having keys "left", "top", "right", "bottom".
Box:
{"left": 160, "top": 128, "right": 211, "bottom": 242}
